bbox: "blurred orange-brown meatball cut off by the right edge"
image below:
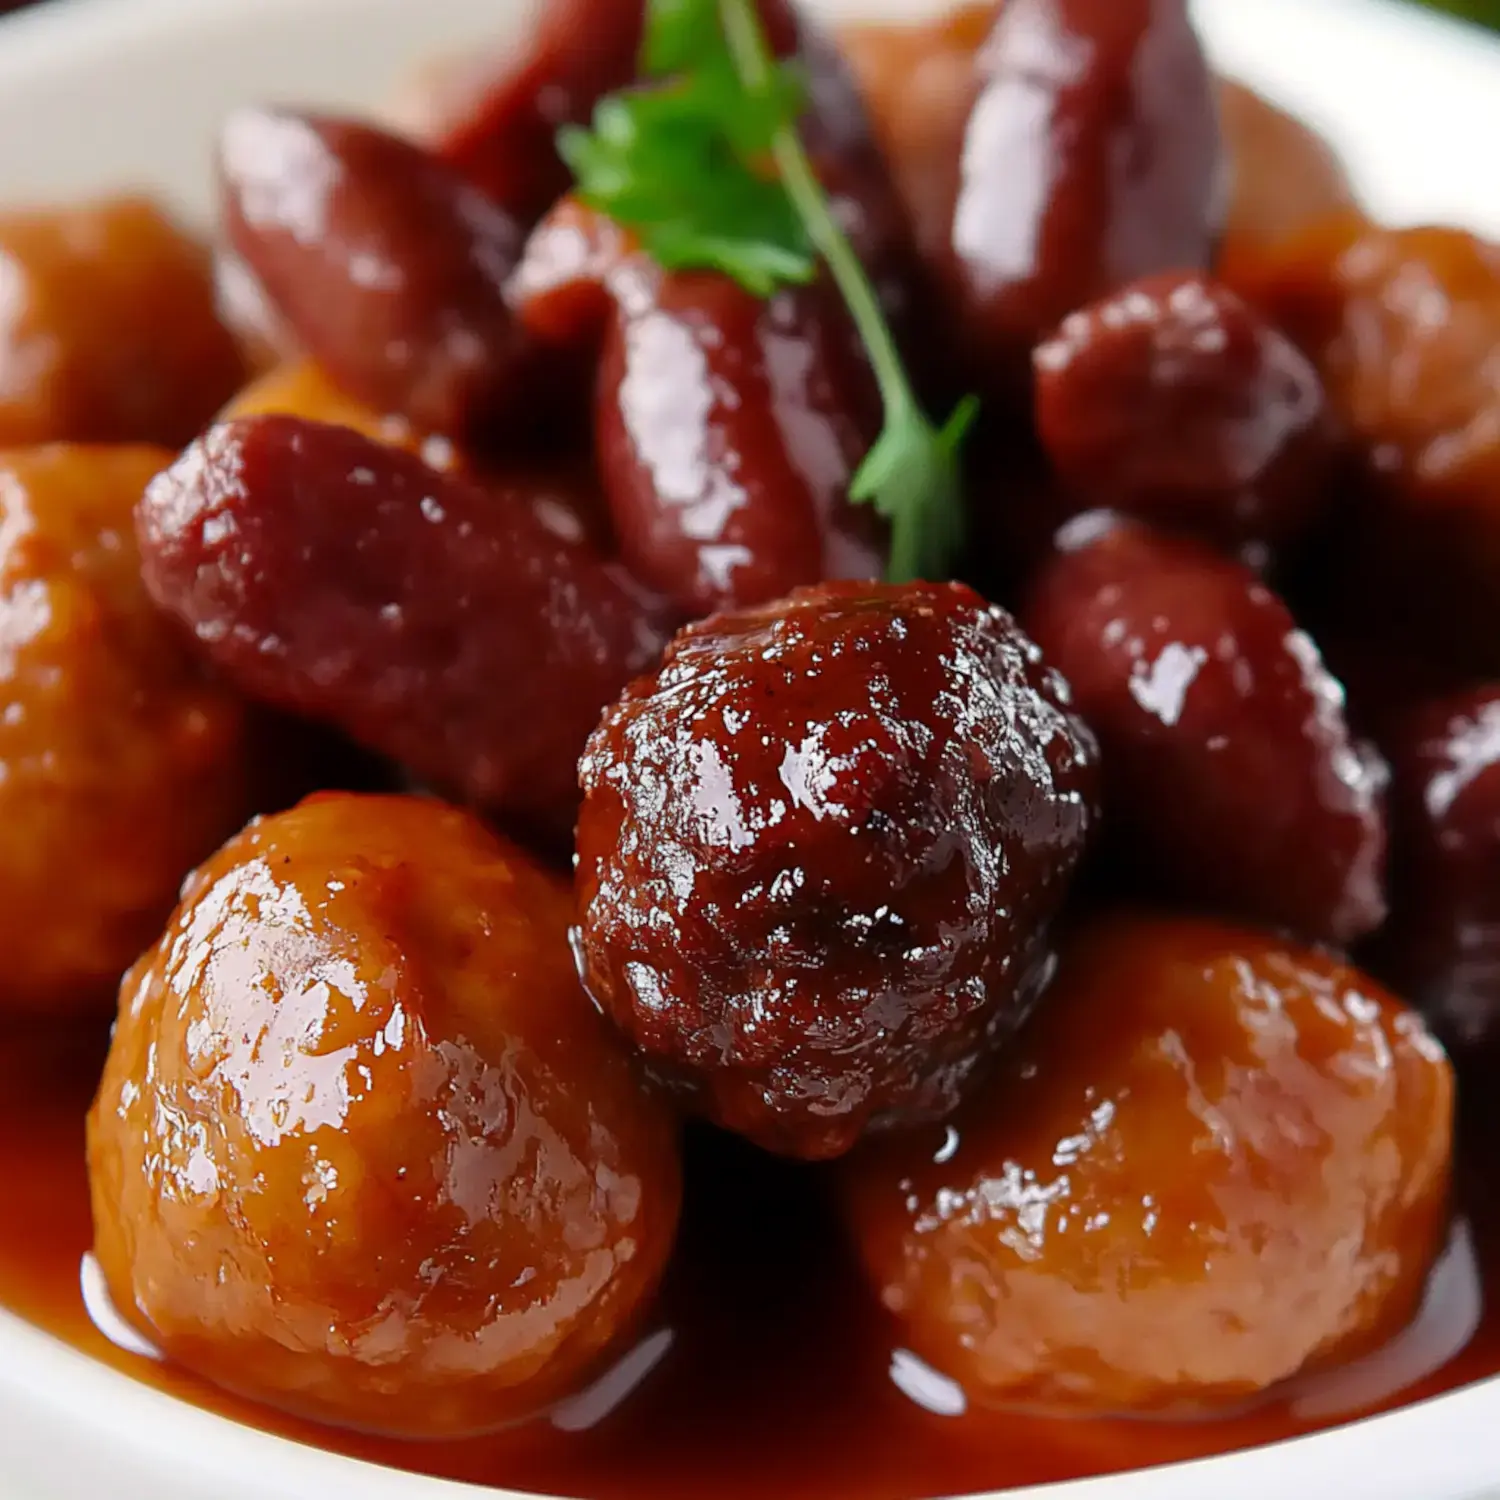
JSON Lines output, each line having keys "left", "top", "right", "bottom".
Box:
{"left": 1241, "top": 216, "right": 1500, "bottom": 677}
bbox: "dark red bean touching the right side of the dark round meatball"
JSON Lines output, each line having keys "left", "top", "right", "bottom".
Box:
{"left": 1023, "top": 513, "right": 1388, "bottom": 944}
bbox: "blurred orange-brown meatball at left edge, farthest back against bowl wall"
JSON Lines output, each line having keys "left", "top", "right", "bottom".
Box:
{"left": 0, "top": 198, "right": 243, "bottom": 447}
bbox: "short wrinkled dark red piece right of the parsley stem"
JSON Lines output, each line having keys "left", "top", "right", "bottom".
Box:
{"left": 1032, "top": 272, "right": 1337, "bottom": 558}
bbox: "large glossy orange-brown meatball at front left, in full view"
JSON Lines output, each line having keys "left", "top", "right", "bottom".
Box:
{"left": 89, "top": 795, "right": 680, "bottom": 1437}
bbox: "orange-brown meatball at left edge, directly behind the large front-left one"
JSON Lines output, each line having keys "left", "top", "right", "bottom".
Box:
{"left": 0, "top": 446, "right": 249, "bottom": 1016}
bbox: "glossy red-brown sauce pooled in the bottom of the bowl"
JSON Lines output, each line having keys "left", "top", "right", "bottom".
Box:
{"left": 0, "top": 1032, "right": 1500, "bottom": 1500}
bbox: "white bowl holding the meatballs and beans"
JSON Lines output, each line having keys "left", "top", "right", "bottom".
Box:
{"left": 0, "top": 0, "right": 1500, "bottom": 1500}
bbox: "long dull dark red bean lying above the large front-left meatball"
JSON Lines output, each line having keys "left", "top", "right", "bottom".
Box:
{"left": 138, "top": 416, "right": 663, "bottom": 833}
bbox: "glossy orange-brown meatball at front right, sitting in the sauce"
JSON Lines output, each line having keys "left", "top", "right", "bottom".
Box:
{"left": 842, "top": 915, "right": 1454, "bottom": 1412}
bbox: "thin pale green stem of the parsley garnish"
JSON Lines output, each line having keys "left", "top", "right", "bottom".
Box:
{"left": 719, "top": 0, "right": 927, "bottom": 425}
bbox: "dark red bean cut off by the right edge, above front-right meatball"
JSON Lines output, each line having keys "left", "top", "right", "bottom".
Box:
{"left": 1379, "top": 684, "right": 1500, "bottom": 1052}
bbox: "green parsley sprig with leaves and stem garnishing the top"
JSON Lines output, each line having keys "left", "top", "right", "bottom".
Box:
{"left": 558, "top": 0, "right": 978, "bottom": 582}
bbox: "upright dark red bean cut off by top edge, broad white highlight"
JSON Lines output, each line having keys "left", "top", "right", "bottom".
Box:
{"left": 942, "top": 0, "right": 1223, "bottom": 387}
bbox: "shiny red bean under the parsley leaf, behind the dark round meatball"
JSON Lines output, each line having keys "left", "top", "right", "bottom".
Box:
{"left": 596, "top": 273, "right": 882, "bottom": 615}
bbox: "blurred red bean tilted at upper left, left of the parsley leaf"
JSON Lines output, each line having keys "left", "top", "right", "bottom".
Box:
{"left": 219, "top": 110, "right": 533, "bottom": 435}
